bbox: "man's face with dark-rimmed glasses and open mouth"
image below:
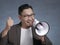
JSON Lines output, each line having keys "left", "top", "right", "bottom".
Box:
{"left": 20, "top": 8, "right": 34, "bottom": 26}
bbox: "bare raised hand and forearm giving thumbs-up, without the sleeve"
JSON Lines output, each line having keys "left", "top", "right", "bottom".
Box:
{"left": 2, "top": 17, "right": 13, "bottom": 38}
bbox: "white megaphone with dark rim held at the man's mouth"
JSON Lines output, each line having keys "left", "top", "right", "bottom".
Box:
{"left": 33, "top": 19, "right": 50, "bottom": 36}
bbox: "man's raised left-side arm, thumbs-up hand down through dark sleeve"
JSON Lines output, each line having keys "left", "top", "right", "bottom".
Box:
{"left": 0, "top": 17, "right": 13, "bottom": 43}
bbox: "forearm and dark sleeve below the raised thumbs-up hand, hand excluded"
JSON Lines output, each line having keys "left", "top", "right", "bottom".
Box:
{"left": 0, "top": 27, "right": 9, "bottom": 45}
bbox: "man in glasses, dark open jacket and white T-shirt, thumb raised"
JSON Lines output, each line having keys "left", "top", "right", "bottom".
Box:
{"left": 0, "top": 4, "right": 51, "bottom": 45}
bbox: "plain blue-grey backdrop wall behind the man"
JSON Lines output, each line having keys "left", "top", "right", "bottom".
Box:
{"left": 0, "top": 0, "right": 60, "bottom": 45}
